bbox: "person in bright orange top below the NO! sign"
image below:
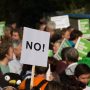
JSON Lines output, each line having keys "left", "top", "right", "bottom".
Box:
{"left": 19, "top": 66, "right": 48, "bottom": 90}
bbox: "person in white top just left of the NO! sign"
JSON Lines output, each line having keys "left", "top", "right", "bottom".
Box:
{"left": 9, "top": 42, "right": 23, "bottom": 74}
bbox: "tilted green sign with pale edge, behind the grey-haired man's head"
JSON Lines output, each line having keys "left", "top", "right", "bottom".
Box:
{"left": 54, "top": 39, "right": 71, "bottom": 60}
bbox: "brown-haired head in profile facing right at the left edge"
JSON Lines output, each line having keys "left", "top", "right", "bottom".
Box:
{"left": 0, "top": 41, "right": 13, "bottom": 61}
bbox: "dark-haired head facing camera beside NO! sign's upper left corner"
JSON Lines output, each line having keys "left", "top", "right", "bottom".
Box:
{"left": 11, "top": 28, "right": 23, "bottom": 41}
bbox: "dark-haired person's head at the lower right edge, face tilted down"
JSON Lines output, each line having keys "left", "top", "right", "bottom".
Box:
{"left": 74, "top": 64, "right": 90, "bottom": 84}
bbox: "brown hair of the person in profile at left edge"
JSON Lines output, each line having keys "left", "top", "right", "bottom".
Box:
{"left": 0, "top": 41, "right": 12, "bottom": 61}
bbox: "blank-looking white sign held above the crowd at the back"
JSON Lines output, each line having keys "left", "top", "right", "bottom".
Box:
{"left": 51, "top": 15, "right": 70, "bottom": 29}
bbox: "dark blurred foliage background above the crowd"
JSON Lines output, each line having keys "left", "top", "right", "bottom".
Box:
{"left": 0, "top": 0, "right": 90, "bottom": 27}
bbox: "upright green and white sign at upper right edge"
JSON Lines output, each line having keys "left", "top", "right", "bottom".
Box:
{"left": 78, "top": 19, "right": 90, "bottom": 39}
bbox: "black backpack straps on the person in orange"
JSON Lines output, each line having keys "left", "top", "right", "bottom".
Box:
{"left": 25, "top": 79, "right": 47, "bottom": 90}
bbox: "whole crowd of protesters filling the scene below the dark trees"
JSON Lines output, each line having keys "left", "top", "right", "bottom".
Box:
{"left": 0, "top": 17, "right": 90, "bottom": 90}
